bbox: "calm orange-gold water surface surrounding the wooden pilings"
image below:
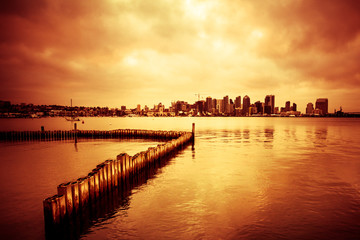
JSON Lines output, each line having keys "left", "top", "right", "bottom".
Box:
{"left": 0, "top": 118, "right": 360, "bottom": 239}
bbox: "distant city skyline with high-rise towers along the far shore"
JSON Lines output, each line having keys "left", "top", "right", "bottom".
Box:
{"left": 0, "top": 95, "right": 344, "bottom": 118}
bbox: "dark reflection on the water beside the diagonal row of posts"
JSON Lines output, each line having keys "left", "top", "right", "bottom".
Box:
{"left": 45, "top": 143, "right": 195, "bottom": 239}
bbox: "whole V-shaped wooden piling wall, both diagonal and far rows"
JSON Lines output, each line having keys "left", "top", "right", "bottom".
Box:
{"left": 41, "top": 124, "right": 195, "bottom": 228}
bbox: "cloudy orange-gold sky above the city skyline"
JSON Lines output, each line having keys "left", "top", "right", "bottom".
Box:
{"left": 0, "top": 0, "right": 360, "bottom": 112}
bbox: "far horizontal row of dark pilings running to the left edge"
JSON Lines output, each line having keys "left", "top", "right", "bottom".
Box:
{"left": 0, "top": 129, "right": 185, "bottom": 141}
